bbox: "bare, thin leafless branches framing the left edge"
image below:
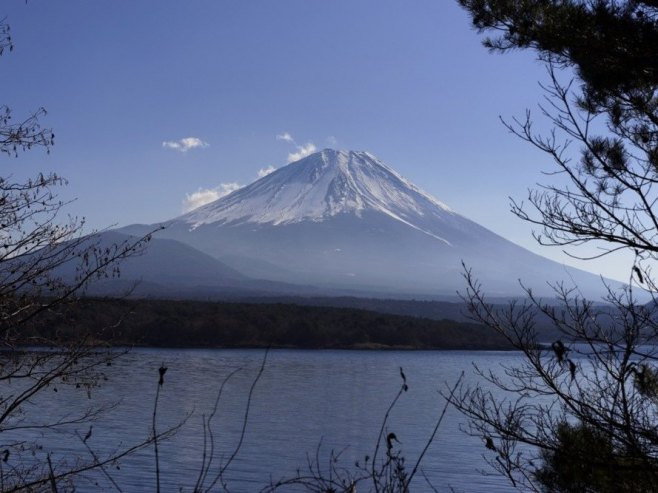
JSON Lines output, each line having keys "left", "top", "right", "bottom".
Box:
{"left": 0, "top": 13, "right": 156, "bottom": 491}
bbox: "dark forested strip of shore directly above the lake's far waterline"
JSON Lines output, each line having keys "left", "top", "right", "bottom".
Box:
{"left": 25, "top": 299, "right": 508, "bottom": 349}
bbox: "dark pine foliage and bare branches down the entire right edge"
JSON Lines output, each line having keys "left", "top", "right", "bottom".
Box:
{"left": 453, "top": 0, "right": 658, "bottom": 492}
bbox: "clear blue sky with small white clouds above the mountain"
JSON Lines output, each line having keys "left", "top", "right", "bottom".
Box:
{"left": 0, "top": 0, "right": 629, "bottom": 279}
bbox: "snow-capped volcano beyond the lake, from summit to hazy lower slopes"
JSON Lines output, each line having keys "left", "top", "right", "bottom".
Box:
{"left": 120, "top": 149, "right": 602, "bottom": 296}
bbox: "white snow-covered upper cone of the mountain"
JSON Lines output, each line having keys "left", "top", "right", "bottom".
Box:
{"left": 180, "top": 149, "right": 453, "bottom": 228}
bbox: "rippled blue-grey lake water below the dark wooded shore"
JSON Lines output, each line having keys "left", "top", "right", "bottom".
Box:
{"left": 9, "top": 349, "right": 521, "bottom": 492}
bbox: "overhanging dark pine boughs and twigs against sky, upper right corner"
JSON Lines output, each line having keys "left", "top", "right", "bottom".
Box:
{"left": 459, "top": 0, "right": 658, "bottom": 262}
